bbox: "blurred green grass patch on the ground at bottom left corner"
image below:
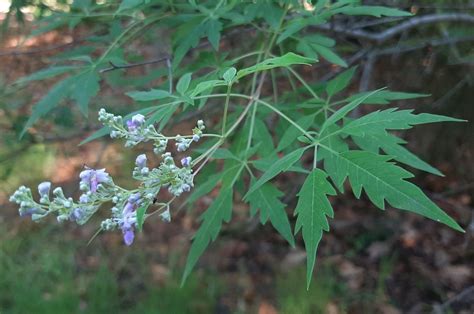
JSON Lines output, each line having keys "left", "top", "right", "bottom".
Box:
{"left": 0, "top": 225, "right": 222, "bottom": 314}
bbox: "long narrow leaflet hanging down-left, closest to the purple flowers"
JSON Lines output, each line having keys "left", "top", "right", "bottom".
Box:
{"left": 181, "top": 188, "right": 232, "bottom": 285}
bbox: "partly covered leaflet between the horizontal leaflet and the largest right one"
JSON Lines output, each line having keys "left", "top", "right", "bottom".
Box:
{"left": 352, "top": 133, "right": 443, "bottom": 176}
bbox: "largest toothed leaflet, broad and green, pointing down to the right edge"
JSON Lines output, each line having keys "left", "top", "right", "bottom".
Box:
{"left": 321, "top": 146, "right": 463, "bottom": 232}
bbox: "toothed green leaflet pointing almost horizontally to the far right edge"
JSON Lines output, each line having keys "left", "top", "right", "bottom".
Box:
{"left": 341, "top": 108, "right": 464, "bottom": 136}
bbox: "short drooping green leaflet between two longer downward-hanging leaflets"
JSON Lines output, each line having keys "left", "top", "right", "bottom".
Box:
{"left": 248, "top": 183, "right": 295, "bottom": 247}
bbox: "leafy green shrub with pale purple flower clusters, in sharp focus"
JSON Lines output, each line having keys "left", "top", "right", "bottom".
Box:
{"left": 11, "top": 0, "right": 463, "bottom": 286}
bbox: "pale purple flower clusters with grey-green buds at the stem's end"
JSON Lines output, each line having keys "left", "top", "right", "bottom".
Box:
{"left": 10, "top": 109, "right": 205, "bottom": 245}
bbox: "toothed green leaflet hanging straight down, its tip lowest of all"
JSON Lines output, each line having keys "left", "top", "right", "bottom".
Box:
{"left": 295, "top": 168, "right": 336, "bottom": 289}
